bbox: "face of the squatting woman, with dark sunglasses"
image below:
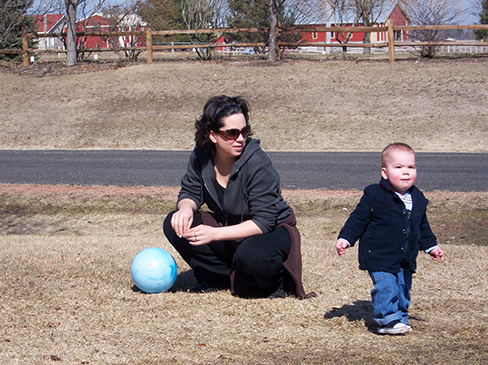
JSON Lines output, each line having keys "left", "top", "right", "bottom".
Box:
{"left": 209, "top": 113, "right": 249, "bottom": 158}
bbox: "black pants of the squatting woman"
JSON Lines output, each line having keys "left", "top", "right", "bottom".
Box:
{"left": 163, "top": 212, "right": 291, "bottom": 289}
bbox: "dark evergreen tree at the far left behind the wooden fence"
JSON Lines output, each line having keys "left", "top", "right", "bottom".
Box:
{"left": 0, "top": 0, "right": 35, "bottom": 61}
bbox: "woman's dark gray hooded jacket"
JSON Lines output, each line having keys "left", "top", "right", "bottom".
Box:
{"left": 178, "top": 138, "right": 290, "bottom": 233}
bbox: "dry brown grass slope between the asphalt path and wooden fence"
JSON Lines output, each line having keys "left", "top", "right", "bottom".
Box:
{"left": 0, "top": 57, "right": 488, "bottom": 152}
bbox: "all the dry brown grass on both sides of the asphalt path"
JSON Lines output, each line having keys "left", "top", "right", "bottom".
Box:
{"left": 0, "top": 58, "right": 488, "bottom": 365}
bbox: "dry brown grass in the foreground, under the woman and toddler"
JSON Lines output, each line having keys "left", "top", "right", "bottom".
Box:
{"left": 0, "top": 185, "right": 488, "bottom": 364}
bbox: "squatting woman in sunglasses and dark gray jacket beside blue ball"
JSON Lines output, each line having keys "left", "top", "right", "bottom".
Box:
{"left": 164, "top": 95, "right": 313, "bottom": 298}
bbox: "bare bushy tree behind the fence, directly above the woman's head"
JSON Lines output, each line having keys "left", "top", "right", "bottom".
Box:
{"left": 181, "top": 0, "right": 227, "bottom": 60}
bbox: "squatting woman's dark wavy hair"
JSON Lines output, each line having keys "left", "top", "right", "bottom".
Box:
{"left": 195, "top": 95, "right": 249, "bottom": 150}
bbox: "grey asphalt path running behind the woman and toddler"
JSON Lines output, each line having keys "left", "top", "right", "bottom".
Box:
{"left": 0, "top": 150, "right": 488, "bottom": 191}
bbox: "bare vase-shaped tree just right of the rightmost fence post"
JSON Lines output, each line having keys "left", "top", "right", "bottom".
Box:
{"left": 400, "top": 0, "right": 463, "bottom": 58}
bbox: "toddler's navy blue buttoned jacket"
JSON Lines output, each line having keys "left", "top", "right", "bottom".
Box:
{"left": 339, "top": 179, "right": 437, "bottom": 273}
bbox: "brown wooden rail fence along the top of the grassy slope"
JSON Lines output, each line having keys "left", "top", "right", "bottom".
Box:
{"left": 0, "top": 20, "right": 488, "bottom": 66}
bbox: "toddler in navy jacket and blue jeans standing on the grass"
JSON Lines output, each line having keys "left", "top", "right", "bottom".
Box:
{"left": 336, "top": 143, "right": 444, "bottom": 335}
